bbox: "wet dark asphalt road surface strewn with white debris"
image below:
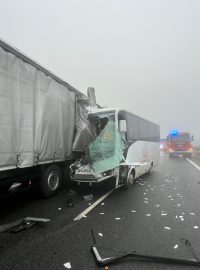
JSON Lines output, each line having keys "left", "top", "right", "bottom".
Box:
{"left": 0, "top": 154, "right": 200, "bottom": 270}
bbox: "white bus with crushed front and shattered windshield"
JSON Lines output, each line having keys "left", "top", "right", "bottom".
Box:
{"left": 70, "top": 109, "right": 160, "bottom": 188}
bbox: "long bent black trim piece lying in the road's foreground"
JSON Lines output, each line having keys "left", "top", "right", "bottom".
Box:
{"left": 91, "top": 246, "right": 200, "bottom": 266}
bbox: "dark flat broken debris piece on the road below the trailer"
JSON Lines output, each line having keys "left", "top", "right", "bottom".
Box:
{"left": 0, "top": 217, "right": 50, "bottom": 233}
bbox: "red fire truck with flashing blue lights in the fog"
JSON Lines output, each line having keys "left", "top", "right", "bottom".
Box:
{"left": 166, "top": 130, "right": 193, "bottom": 157}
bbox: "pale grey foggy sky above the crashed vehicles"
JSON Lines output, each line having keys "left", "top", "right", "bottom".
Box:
{"left": 0, "top": 0, "right": 200, "bottom": 142}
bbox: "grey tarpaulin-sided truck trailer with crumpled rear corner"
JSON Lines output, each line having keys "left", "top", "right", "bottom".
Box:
{"left": 0, "top": 40, "right": 95, "bottom": 196}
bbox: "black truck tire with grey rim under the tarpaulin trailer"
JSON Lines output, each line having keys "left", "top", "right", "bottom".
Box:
{"left": 41, "top": 165, "right": 63, "bottom": 198}
